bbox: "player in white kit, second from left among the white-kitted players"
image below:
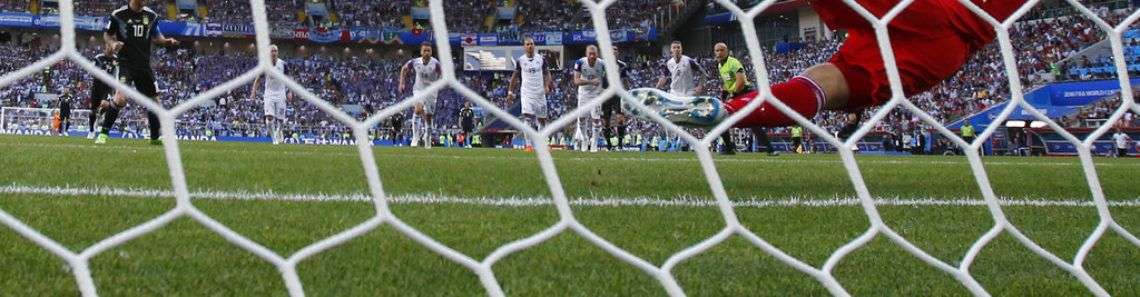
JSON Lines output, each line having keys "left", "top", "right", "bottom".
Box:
{"left": 400, "top": 42, "right": 443, "bottom": 148}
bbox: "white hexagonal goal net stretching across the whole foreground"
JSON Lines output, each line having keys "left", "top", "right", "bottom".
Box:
{"left": 0, "top": 0, "right": 1140, "bottom": 296}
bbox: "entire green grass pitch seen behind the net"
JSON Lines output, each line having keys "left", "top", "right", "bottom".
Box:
{"left": 0, "top": 135, "right": 1140, "bottom": 296}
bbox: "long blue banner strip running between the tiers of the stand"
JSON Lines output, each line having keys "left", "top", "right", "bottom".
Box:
{"left": 0, "top": 13, "right": 657, "bottom": 47}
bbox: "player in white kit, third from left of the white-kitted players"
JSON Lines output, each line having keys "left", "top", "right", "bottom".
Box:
{"left": 506, "top": 36, "right": 554, "bottom": 151}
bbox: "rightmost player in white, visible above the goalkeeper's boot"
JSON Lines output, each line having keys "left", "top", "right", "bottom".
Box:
{"left": 657, "top": 41, "right": 708, "bottom": 97}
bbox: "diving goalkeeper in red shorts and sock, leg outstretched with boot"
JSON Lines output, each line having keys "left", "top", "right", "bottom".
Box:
{"left": 627, "top": 0, "right": 1025, "bottom": 127}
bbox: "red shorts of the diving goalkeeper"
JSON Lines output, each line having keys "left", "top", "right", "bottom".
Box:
{"left": 812, "top": 0, "right": 1025, "bottom": 112}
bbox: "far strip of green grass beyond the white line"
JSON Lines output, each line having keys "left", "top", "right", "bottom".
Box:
{"left": 0, "top": 135, "right": 1140, "bottom": 200}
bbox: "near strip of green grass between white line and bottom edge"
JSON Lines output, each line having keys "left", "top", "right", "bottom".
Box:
{"left": 0, "top": 195, "right": 1140, "bottom": 296}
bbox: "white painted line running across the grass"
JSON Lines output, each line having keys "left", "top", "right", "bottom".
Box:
{"left": 0, "top": 184, "right": 1140, "bottom": 208}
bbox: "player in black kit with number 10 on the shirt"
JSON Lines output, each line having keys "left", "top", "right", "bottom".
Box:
{"left": 95, "top": 0, "right": 178, "bottom": 145}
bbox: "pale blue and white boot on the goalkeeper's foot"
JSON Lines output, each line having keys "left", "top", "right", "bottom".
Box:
{"left": 621, "top": 88, "right": 728, "bottom": 127}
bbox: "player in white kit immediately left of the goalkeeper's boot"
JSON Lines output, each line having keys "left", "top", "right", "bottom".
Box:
{"left": 573, "top": 46, "right": 605, "bottom": 151}
